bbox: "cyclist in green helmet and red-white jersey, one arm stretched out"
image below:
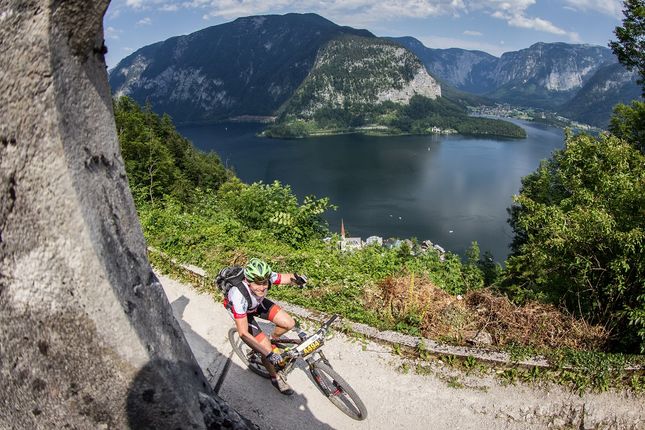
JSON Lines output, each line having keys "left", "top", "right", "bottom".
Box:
{"left": 224, "top": 258, "right": 307, "bottom": 395}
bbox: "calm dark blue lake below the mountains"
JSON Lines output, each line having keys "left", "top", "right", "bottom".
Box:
{"left": 179, "top": 121, "right": 564, "bottom": 261}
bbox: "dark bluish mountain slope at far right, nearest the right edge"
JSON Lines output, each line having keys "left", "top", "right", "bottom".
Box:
{"left": 557, "top": 63, "right": 641, "bottom": 128}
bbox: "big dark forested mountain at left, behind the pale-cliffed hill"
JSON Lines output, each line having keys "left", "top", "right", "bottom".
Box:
{"left": 109, "top": 14, "right": 374, "bottom": 123}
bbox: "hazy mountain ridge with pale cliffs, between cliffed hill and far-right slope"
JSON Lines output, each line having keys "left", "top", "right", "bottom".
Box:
{"left": 392, "top": 37, "right": 617, "bottom": 109}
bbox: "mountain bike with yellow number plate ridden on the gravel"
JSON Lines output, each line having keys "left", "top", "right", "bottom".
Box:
{"left": 228, "top": 315, "right": 367, "bottom": 421}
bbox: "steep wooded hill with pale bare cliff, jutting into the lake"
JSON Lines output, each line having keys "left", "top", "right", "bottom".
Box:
{"left": 264, "top": 36, "right": 526, "bottom": 138}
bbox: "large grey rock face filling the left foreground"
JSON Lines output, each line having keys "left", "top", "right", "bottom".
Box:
{"left": 0, "top": 0, "right": 253, "bottom": 429}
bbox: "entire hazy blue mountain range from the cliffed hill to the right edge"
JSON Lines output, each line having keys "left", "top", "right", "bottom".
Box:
{"left": 390, "top": 37, "right": 640, "bottom": 127}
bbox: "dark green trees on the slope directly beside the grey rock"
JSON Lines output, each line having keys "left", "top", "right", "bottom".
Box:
{"left": 114, "top": 97, "right": 231, "bottom": 203}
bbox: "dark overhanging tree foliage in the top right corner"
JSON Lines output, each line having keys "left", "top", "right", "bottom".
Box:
{"left": 609, "top": 0, "right": 645, "bottom": 96}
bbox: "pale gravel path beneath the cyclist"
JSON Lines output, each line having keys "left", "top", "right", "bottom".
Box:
{"left": 160, "top": 276, "right": 645, "bottom": 430}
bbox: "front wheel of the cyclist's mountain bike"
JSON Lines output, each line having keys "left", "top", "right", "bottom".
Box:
{"left": 311, "top": 361, "right": 367, "bottom": 421}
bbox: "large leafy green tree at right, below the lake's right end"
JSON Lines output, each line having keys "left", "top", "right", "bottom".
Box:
{"left": 506, "top": 135, "right": 645, "bottom": 350}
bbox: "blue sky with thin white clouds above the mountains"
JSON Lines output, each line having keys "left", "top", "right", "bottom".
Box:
{"left": 103, "top": 0, "right": 623, "bottom": 68}
